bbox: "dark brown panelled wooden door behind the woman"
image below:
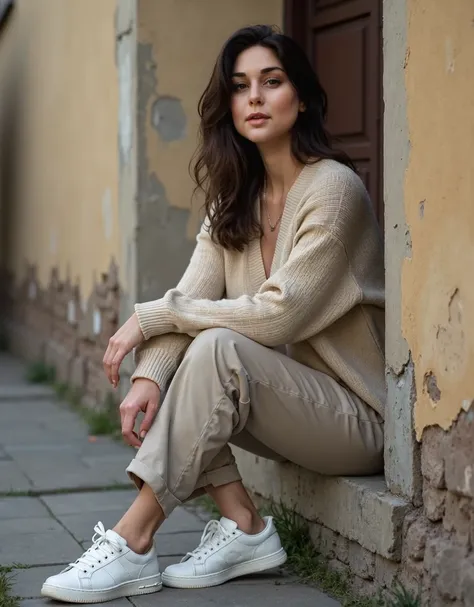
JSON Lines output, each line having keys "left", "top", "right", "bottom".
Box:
{"left": 285, "top": 0, "right": 383, "bottom": 225}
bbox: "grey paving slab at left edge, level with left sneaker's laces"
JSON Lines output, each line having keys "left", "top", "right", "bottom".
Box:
{"left": 0, "top": 529, "right": 82, "bottom": 565}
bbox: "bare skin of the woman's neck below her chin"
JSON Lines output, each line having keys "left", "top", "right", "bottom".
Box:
{"left": 260, "top": 142, "right": 303, "bottom": 201}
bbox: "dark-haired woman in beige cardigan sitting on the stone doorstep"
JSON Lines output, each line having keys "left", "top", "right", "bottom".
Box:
{"left": 43, "top": 26, "right": 385, "bottom": 602}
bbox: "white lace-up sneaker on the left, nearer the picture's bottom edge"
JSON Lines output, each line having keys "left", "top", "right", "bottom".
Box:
{"left": 41, "top": 522, "right": 161, "bottom": 603}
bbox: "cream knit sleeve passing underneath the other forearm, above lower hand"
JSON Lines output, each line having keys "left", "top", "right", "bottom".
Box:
{"left": 131, "top": 222, "right": 225, "bottom": 388}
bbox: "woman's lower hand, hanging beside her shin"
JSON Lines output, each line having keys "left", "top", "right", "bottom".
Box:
{"left": 120, "top": 378, "right": 160, "bottom": 447}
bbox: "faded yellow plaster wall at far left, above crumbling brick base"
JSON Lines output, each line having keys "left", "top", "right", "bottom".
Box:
{"left": 0, "top": 0, "right": 119, "bottom": 298}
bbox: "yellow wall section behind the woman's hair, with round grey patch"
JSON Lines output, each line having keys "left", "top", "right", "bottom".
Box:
{"left": 138, "top": 0, "right": 283, "bottom": 236}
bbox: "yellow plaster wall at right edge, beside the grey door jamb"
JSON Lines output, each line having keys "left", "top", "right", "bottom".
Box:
{"left": 402, "top": 0, "right": 474, "bottom": 437}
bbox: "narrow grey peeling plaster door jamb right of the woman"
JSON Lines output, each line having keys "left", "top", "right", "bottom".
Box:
{"left": 383, "top": 0, "right": 422, "bottom": 505}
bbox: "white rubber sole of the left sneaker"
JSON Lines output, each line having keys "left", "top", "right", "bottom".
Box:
{"left": 41, "top": 575, "right": 163, "bottom": 603}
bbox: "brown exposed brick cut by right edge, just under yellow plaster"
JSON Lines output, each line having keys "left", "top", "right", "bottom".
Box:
{"left": 446, "top": 407, "right": 474, "bottom": 498}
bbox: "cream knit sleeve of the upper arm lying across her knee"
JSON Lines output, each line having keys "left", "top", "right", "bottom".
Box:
{"left": 135, "top": 196, "right": 362, "bottom": 347}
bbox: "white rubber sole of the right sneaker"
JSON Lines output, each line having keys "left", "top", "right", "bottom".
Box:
{"left": 161, "top": 548, "right": 288, "bottom": 588}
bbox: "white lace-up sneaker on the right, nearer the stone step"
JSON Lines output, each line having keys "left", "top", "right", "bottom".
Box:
{"left": 162, "top": 516, "right": 287, "bottom": 588}
